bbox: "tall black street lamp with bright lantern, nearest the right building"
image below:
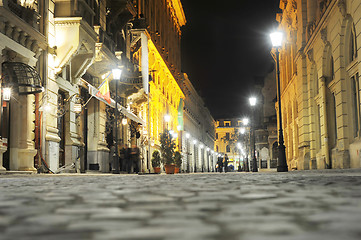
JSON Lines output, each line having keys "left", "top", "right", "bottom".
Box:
{"left": 270, "top": 31, "right": 288, "bottom": 172}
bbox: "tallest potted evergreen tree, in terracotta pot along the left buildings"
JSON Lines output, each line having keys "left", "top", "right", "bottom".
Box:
{"left": 160, "top": 129, "right": 175, "bottom": 174}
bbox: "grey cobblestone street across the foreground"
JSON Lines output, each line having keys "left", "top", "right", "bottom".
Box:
{"left": 0, "top": 169, "right": 361, "bottom": 240}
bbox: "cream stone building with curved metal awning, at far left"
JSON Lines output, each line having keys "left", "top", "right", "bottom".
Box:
{"left": 0, "top": 0, "right": 48, "bottom": 171}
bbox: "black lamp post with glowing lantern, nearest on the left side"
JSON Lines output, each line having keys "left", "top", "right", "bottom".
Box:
{"left": 112, "top": 68, "right": 122, "bottom": 174}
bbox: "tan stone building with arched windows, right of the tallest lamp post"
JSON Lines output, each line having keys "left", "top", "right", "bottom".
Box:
{"left": 277, "top": 0, "right": 361, "bottom": 169}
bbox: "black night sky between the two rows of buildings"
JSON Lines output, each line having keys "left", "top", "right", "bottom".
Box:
{"left": 181, "top": 0, "right": 280, "bottom": 119}
